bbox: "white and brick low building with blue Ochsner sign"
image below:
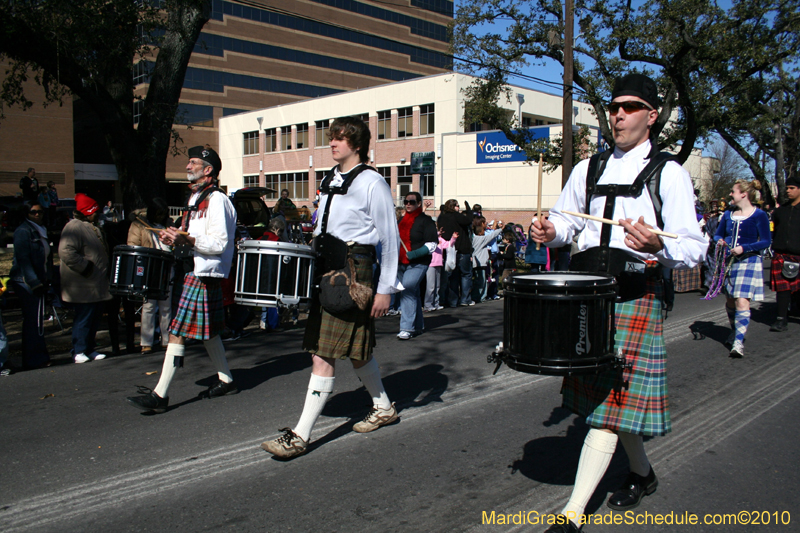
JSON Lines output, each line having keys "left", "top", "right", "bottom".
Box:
{"left": 219, "top": 73, "right": 597, "bottom": 223}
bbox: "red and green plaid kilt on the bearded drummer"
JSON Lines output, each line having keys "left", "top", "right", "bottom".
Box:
{"left": 169, "top": 272, "right": 225, "bottom": 341}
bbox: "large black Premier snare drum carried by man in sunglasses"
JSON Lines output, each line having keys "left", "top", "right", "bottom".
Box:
{"left": 497, "top": 272, "right": 616, "bottom": 376}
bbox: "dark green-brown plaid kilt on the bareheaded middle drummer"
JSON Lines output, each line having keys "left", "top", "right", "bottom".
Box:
{"left": 303, "top": 246, "right": 375, "bottom": 361}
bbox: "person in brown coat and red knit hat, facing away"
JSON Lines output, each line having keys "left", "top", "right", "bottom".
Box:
{"left": 58, "top": 193, "right": 111, "bottom": 363}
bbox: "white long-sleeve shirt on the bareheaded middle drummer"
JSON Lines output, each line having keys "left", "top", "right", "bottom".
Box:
{"left": 314, "top": 167, "right": 403, "bottom": 294}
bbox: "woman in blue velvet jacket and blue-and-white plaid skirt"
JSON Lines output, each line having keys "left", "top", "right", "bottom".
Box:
{"left": 714, "top": 180, "right": 771, "bottom": 357}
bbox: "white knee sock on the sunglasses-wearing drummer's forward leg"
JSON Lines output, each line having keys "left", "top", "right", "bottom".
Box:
{"left": 561, "top": 428, "right": 617, "bottom": 526}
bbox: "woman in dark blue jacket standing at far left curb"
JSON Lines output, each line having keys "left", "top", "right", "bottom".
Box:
{"left": 10, "top": 204, "right": 53, "bottom": 369}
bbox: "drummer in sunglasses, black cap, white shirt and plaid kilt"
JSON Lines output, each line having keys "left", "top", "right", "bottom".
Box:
{"left": 531, "top": 74, "right": 707, "bottom": 533}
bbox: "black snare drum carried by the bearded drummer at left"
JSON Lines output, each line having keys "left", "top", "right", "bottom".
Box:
{"left": 109, "top": 246, "right": 175, "bottom": 300}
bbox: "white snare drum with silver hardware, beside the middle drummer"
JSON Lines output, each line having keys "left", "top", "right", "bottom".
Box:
{"left": 234, "top": 240, "right": 316, "bottom": 308}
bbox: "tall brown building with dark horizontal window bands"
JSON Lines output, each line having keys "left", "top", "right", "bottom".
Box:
{"left": 134, "top": 0, "right": 453, "bottom": 200}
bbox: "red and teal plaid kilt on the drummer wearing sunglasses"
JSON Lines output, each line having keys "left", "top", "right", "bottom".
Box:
{"left": 561, "top": 280, "right": 672, "bottom": 436}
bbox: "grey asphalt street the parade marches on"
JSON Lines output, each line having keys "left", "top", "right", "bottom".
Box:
{"left": 0, "top": 291, "right": 800, "bottom": 533}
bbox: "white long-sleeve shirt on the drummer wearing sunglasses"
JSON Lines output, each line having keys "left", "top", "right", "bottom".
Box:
{"left": 547, "top": 141, "right": 708, "bottom": 269}
